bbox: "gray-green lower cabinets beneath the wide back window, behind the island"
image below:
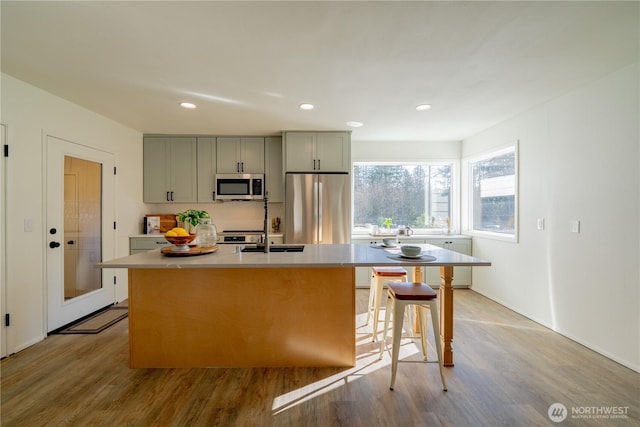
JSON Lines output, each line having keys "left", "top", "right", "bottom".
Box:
{"left": 351, "top": 236, "right": 472, "bottom": 288}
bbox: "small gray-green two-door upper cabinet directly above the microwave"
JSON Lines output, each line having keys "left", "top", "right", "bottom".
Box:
{"left": 216, "top": 137, "right": 264, "bottom": 173}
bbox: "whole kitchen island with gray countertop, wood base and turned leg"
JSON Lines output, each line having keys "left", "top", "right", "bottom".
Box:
{"left": 99, "top": 244, "right": 490, "bottom": 368}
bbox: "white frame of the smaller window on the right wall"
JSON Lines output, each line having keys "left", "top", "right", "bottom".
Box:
{"left": 462, "top": 141, "right": 520, "bottom": 243}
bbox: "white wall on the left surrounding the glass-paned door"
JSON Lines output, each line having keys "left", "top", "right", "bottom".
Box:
{"left": 0, "top": 74, "right": 145, "bottom": 353}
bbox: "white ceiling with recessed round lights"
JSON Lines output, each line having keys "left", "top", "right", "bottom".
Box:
{"left": 1, "top": 0, "right": 640, "bottom": 141}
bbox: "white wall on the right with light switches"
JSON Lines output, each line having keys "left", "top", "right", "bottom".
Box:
{"left": 462, "top": 63, "right": 640, "bottom": 371}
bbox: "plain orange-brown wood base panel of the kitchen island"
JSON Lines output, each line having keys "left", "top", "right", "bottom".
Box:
{"left": 129, "top": 267, "right": 356, "bottom": 368}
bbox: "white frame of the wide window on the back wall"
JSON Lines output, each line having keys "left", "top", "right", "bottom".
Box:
{"left": 351, "top": 158, "right": 461, "bottom": 237}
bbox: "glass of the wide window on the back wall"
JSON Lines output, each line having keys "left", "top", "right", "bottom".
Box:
{"left": 353, "top": 162, "right": 454, "bottom": 233}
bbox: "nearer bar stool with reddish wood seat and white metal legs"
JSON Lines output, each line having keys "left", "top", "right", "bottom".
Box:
{"left": 380, "top": 282, "right": 447, "bottom": 391}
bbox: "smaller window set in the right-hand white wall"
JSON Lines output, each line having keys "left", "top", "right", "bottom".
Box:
{"left": 468, "top": 144, "right": 518, "bottom": 241}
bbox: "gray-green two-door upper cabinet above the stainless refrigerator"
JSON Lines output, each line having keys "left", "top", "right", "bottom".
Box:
{"left": 284, "top": 132, "right": 351, "bottom": 172}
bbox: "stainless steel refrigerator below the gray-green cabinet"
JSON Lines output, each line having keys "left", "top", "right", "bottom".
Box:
{"left": 284, "top": 173, "right": 351, "bottom": 244}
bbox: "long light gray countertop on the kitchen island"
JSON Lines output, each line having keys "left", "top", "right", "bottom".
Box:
{"left": 97, "top": 244, "right": 491, "bottom": 268}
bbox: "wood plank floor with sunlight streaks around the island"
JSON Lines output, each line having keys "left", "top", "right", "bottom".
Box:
{"left": 0, "top": 290, "right": 640, "bottom": 427}
